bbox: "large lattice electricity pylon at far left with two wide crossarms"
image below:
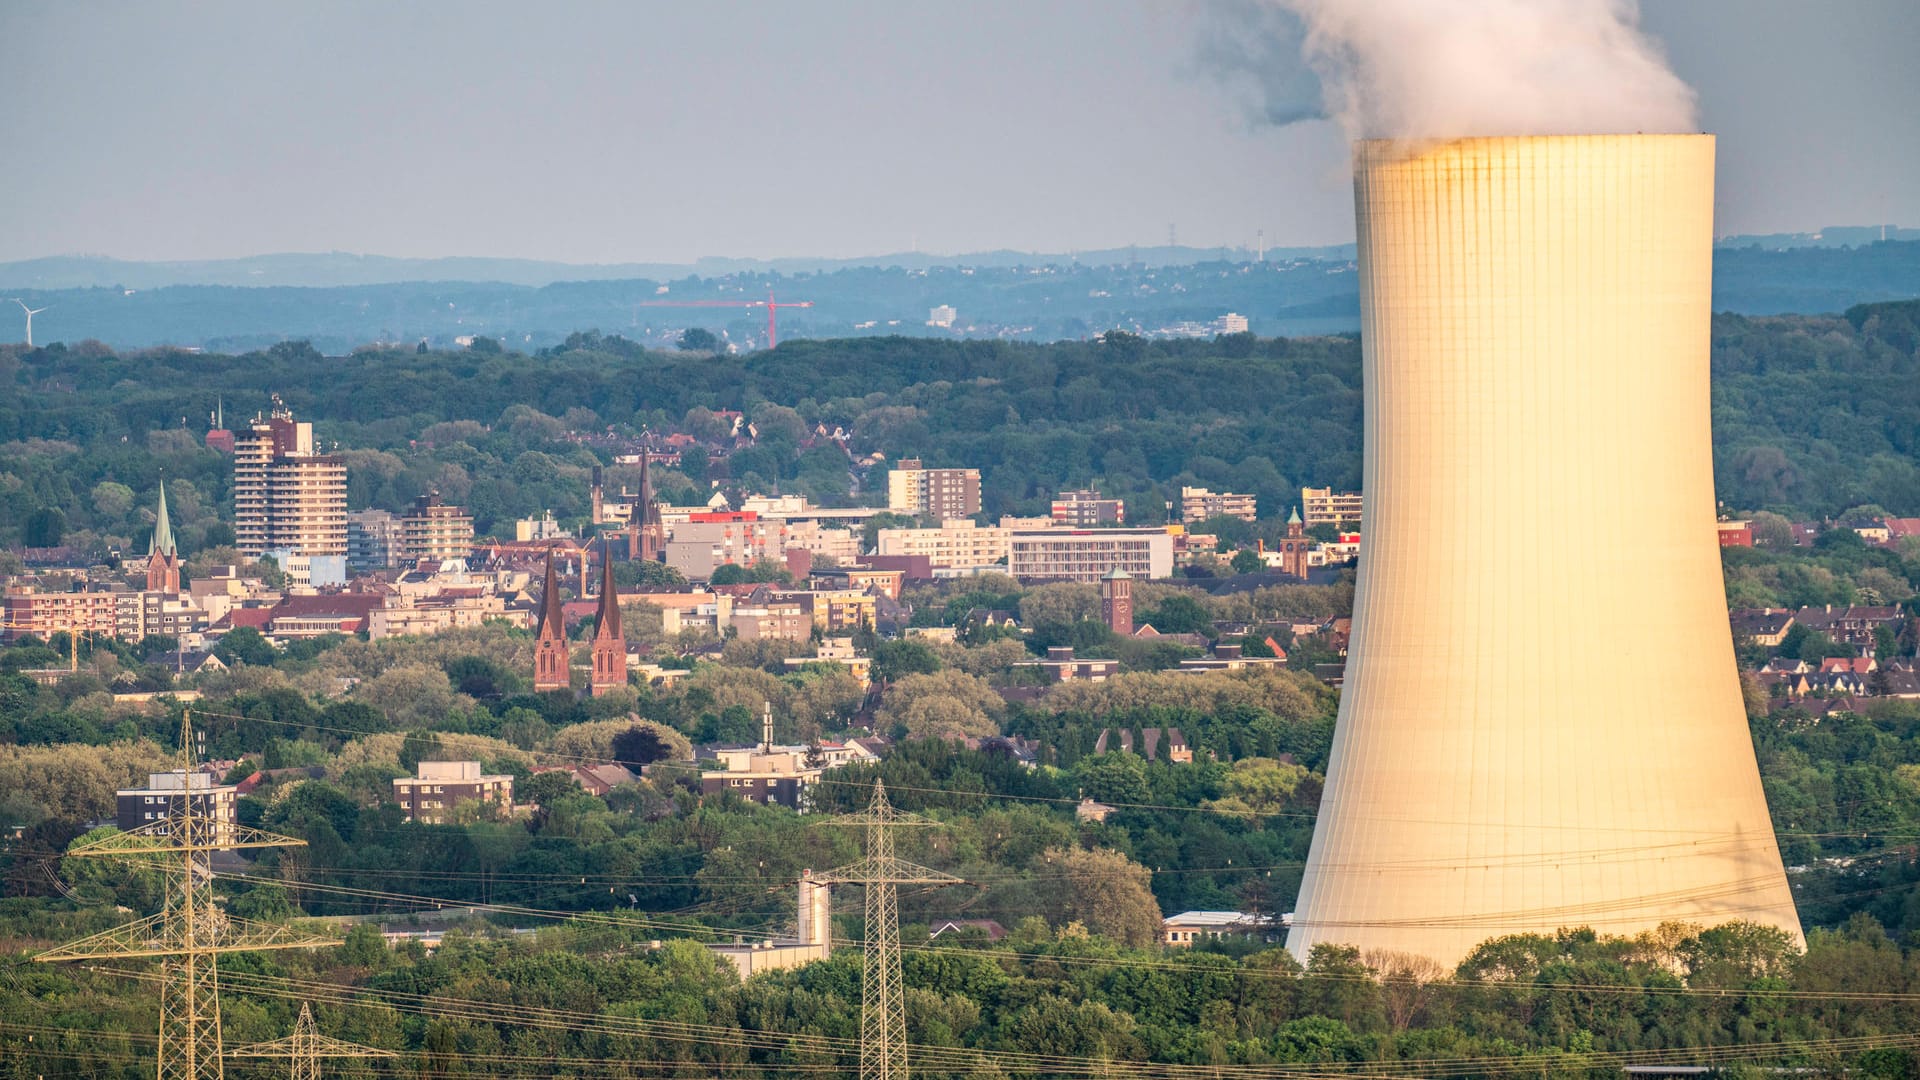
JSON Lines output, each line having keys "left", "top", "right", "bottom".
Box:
{"left": 33, "top": 713, "right": 340, "bottom": 1080}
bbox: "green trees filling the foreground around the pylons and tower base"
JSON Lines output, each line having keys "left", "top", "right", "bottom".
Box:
{"left": 0, "top": 618, "right": 1920, "bottom": 1080}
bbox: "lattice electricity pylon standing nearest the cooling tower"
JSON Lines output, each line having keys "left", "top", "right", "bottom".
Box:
{"left": 820, "top": 780, "right": 966, "bottom": 1080}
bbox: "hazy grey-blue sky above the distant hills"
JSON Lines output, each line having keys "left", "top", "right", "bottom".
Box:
{"left": 0, "top": 0, "right": 1920, "bottom": 261}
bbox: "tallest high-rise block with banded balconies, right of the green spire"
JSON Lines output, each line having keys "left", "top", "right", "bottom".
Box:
{"left": 234, "top": 407, "right": 348, "bottom": 559}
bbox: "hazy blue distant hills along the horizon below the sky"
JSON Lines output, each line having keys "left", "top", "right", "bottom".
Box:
{"left": 0, "top": 240, "right": 1920, "bottom": 356}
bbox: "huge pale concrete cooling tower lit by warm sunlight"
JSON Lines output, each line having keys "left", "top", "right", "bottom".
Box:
{"left": 1286, "top": 135, "right": 1801, "bottom": 965}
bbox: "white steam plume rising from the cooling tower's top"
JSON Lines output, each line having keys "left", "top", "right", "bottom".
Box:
{"left": 1273, "top": 0, "right": 1697, "bottom": 138}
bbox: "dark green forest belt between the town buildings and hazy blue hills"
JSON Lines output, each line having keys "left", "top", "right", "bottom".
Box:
{"left": 0, "top": 302, "right": 1920, "bottom": 550}
